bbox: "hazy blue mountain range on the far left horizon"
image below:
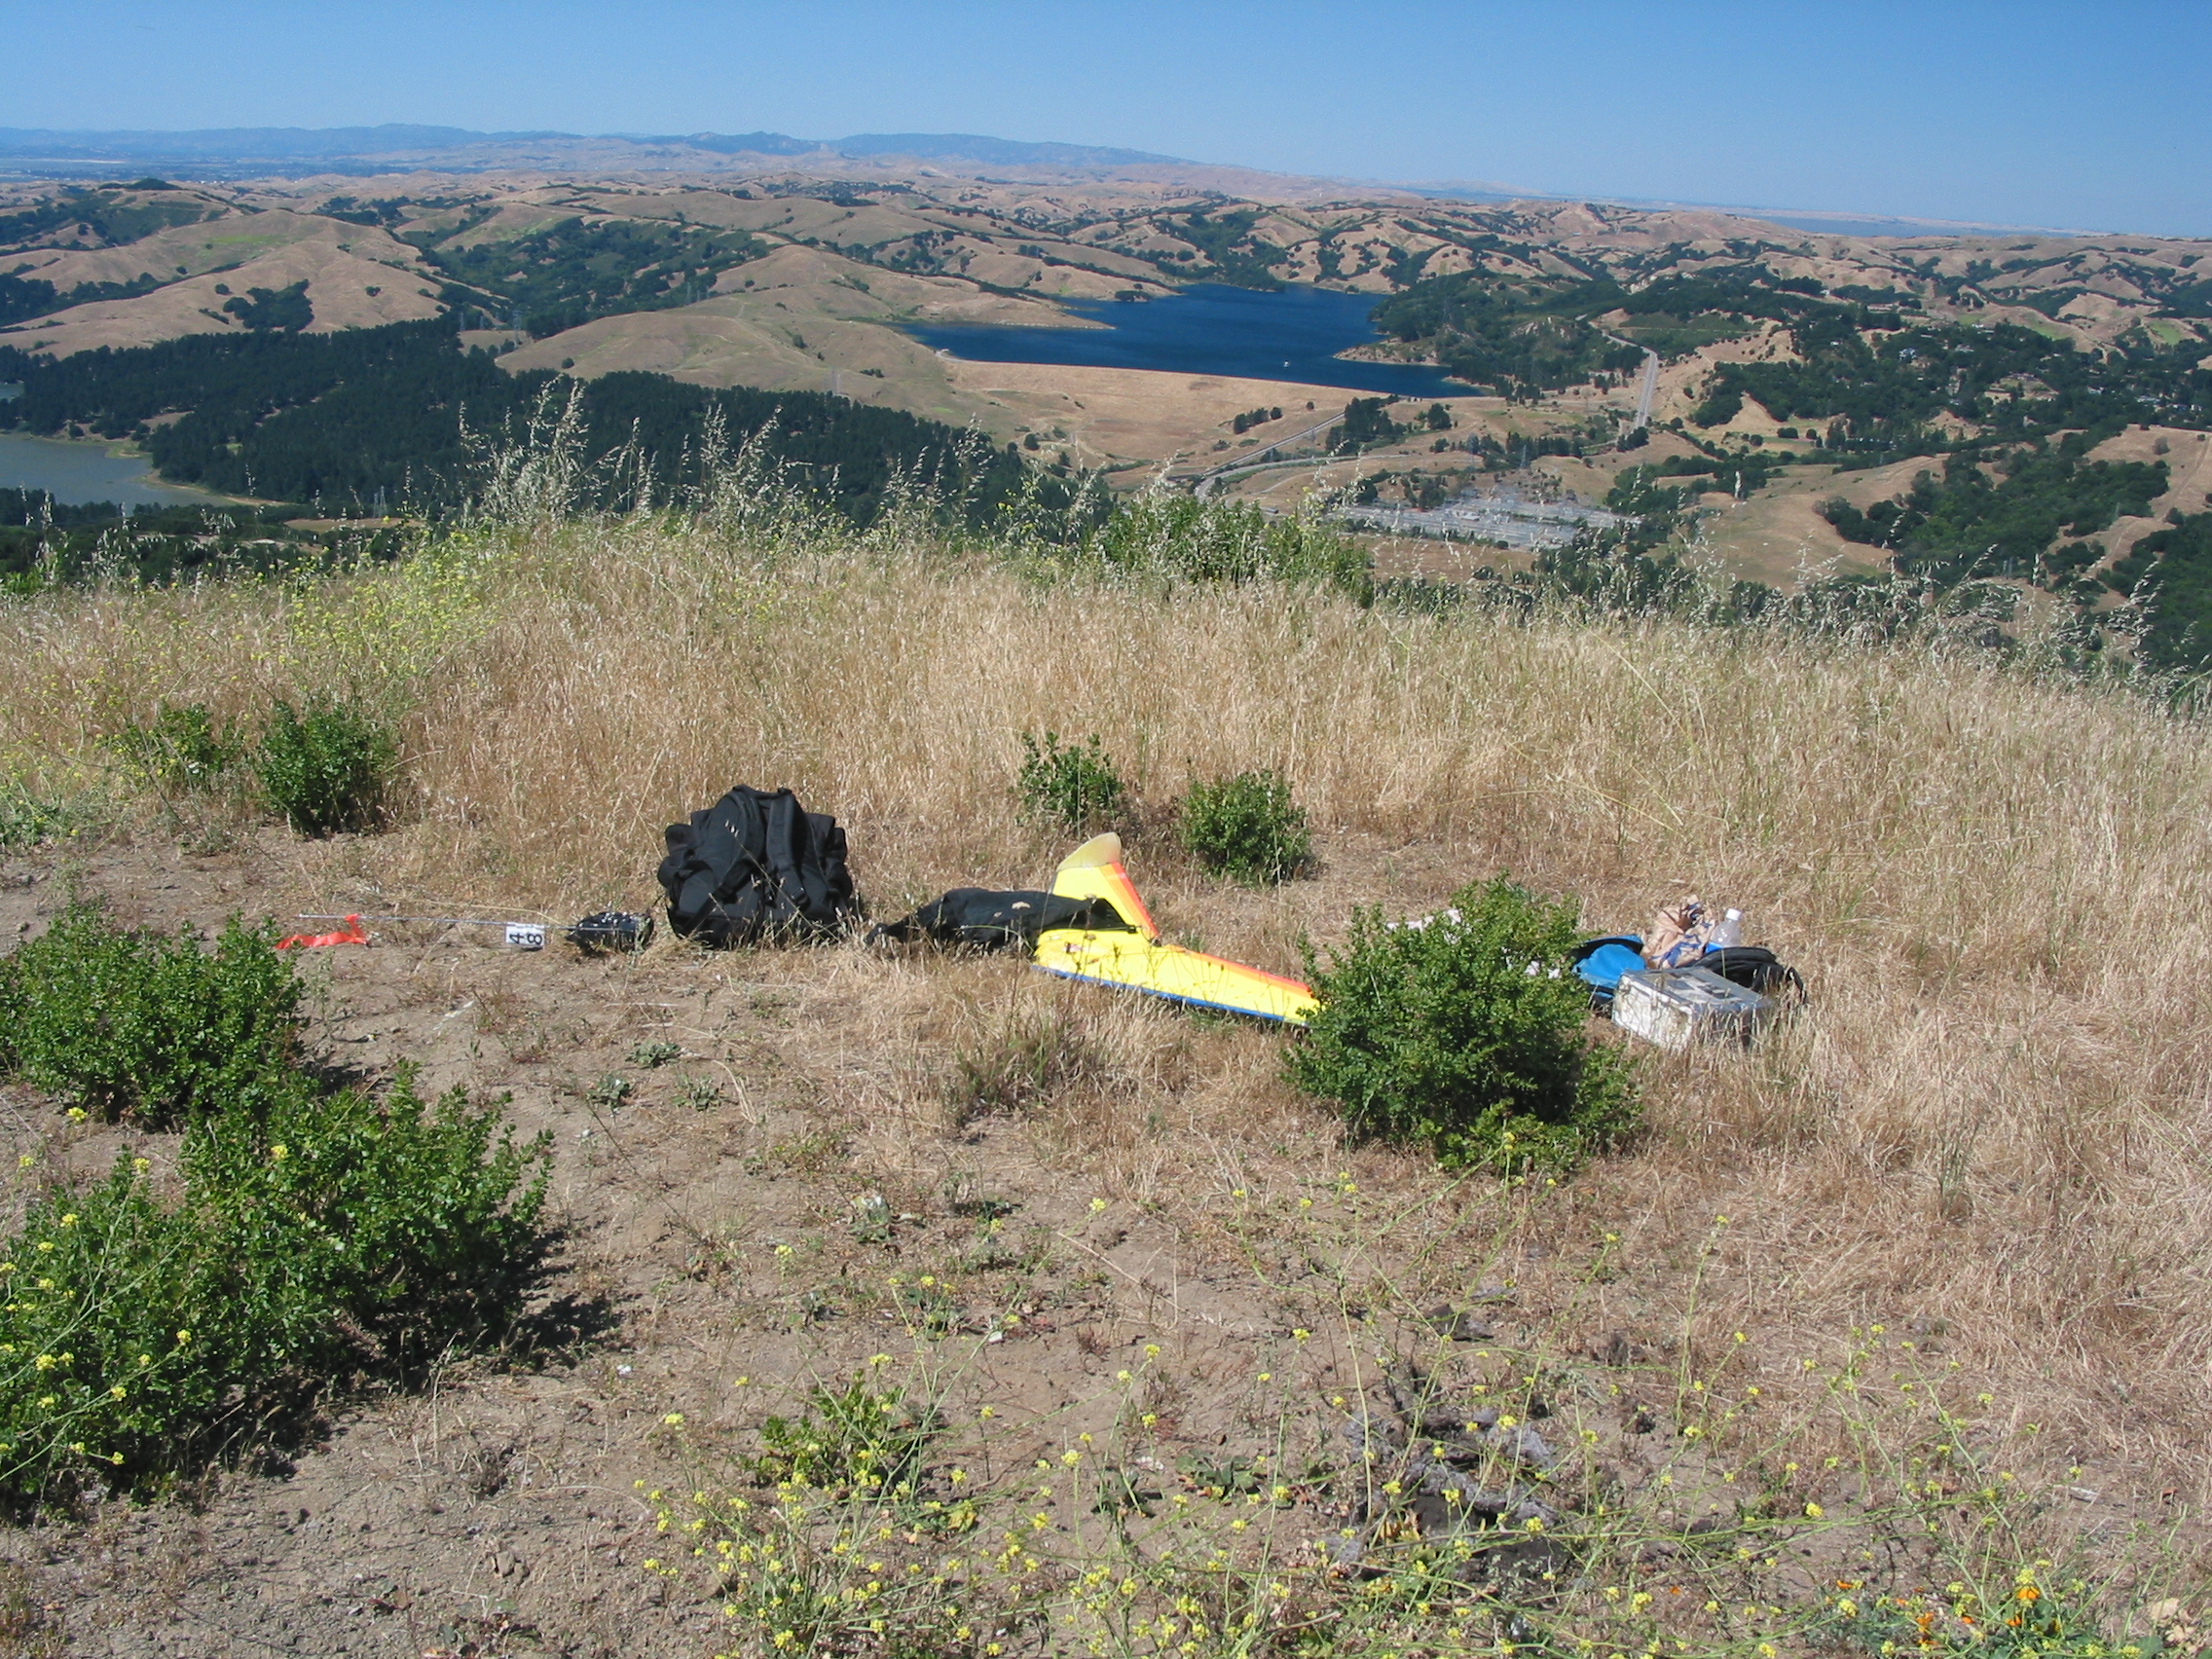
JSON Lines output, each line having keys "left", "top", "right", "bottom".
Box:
{"left": 0, "top": 122, "right": 1188, "bottom": 177}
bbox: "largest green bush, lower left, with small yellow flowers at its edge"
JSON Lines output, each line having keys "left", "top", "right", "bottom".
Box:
{"left": 0, "top": 1075, "right": 546, "bottom": 1504}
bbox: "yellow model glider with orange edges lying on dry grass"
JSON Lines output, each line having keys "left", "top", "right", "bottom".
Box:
{"left": 1038, "top": 834, "right": 1316, "bottom": 1024}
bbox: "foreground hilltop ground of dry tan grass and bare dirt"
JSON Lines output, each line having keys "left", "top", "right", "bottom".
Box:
{"left": 0, "top": 477, "right": 2212, "bottom": 1657}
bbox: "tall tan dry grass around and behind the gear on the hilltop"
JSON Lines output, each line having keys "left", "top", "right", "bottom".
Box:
{"left": 0, "top": 520, "right": 2212, "bottom": 1502}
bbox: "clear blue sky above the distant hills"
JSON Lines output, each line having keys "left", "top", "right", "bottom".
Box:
{"left": 0, "top": 0, "right": 2212, "bottom": 237}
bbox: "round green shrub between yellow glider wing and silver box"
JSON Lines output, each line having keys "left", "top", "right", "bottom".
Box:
{"left": 1290, "top": 876, "right": 1637, "bottom": 1170}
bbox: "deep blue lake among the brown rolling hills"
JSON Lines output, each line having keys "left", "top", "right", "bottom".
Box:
{"left": 907, "top": 283, "right": 1473, "bottom": 398}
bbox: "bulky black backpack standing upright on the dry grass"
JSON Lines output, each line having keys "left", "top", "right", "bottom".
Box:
{"left": 659, "top": 786, "right": 861, "bottom": 951}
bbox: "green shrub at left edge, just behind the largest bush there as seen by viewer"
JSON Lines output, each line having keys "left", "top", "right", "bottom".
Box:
{"left": 0, "top": 901, "right": 301, "bottom": 1128}
